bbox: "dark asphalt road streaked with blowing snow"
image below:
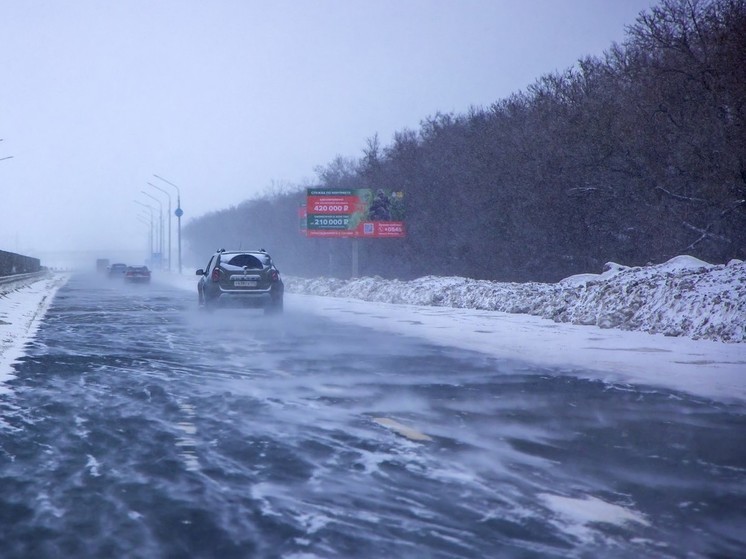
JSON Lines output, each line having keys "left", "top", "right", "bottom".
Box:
{"left": 0, "top": 276, "right": 746, "bottom": 559}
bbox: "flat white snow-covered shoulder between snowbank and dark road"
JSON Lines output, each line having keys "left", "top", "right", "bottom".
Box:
{"left": 285, "top": 294, "right": 746, "bottom": 401}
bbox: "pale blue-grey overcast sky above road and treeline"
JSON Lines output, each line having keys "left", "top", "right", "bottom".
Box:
{"left": 0, "top": 0, "right": 656, "bottom": 255}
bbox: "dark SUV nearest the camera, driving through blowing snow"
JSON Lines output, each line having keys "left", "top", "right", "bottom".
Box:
{"left": 197, "top": 249, "right": 285, "bottom": 314}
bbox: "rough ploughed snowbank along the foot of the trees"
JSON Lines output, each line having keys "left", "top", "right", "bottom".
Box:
{"left": 285, "top": 256, "right": 746, "bottom": 342}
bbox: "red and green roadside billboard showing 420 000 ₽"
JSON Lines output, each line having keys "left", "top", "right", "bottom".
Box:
{"left": 305, "top": 188, "right": 406, "bottom": 239}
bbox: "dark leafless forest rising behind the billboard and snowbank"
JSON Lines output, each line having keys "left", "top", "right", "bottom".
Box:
{"left": 183, "top": 0, "right": 746, "bottom": 281}
